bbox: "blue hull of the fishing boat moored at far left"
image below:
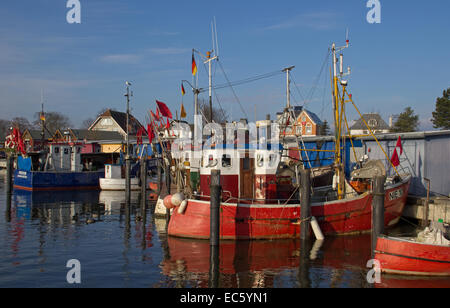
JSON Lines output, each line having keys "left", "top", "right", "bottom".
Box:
{"left": 14, "top": 170, "right": 105, "bottom": 191}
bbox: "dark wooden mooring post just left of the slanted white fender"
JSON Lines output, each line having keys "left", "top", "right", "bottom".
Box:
{"left": 300, "top": 169, "right": 311, "bottom": 240}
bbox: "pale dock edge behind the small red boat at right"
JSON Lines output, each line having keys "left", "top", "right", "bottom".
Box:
{"left": 403, "top": 196, "right": 450, "bottom": 223}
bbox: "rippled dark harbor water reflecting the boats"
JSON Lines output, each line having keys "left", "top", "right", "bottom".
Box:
{"left": 0, "top": 173, "right": 450, "bottom": 288}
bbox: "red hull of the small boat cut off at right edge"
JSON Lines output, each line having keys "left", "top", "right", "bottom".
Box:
{"left": 375, "top": 236, "right": 450, "bottom": 276}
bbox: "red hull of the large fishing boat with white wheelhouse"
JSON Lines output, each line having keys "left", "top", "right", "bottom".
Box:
{"left": 168, "top": 180, "right": 409, "bottom": 240}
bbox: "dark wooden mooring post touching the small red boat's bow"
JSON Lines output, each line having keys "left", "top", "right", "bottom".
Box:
{"left": 372, "top": 175, "right": 386, "bottom": 254}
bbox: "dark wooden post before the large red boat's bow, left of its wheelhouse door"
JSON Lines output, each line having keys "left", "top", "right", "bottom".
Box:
{"left": 210, "top": 170, "right": 222, "bottom": 246}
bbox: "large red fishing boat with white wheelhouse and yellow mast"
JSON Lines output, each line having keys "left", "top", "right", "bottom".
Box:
{"left": 165, "top": 41, "right": 410, "bottom": 240}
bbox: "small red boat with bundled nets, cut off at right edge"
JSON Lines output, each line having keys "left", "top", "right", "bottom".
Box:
{"left": 375, "top": 223, "right": 450, "bottom": 276}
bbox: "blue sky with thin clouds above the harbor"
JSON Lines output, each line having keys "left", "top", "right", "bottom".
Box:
{"left": 0, "top": 0, "right": 450, "bottom": 129}
